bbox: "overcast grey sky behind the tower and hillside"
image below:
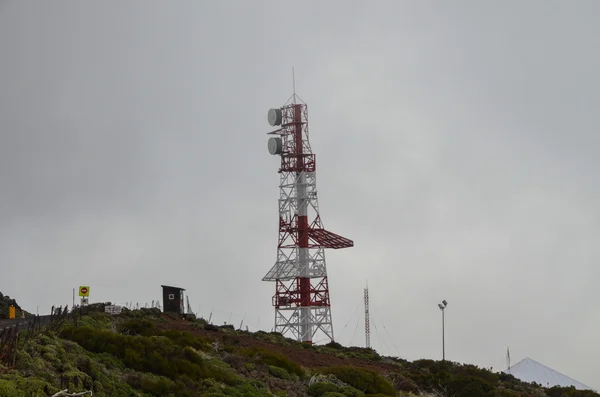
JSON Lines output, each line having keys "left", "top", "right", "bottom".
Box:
{"left": 0, "top": 0, "right": 600, "bottom": 388}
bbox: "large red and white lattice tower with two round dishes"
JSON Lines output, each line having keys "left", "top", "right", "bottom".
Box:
{"left": 263, "top": 93, "right": 354, "bottom": 343}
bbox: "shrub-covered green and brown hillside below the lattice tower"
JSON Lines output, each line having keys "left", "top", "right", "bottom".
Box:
{"left": 0, "top": 305, "right": 599, "bottom": 397}
